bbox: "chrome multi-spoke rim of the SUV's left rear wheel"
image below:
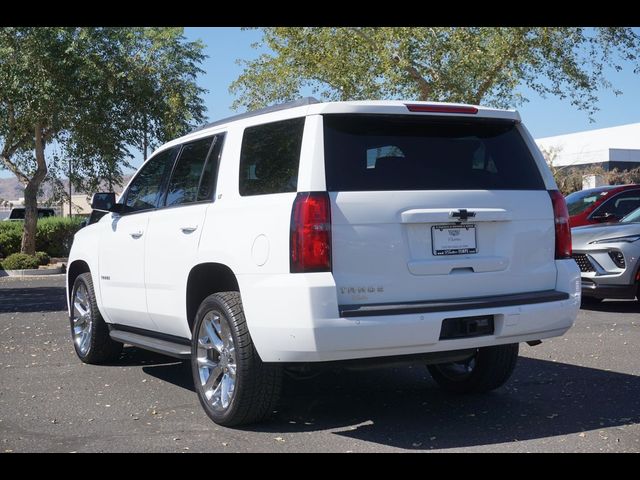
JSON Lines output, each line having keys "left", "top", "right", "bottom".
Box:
{"left": 197, "top": 310, "right": 236, "bottom": 411}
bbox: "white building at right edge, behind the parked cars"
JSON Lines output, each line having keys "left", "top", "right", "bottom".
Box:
{"left": 536, "top": 123, "right": 640, "bottom": 170}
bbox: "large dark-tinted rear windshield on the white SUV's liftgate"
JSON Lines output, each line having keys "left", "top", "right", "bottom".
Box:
{"left": 324, "top": 115, "right": 545, "bottom": 191}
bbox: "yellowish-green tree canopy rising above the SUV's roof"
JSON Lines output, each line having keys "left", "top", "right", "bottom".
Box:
{"left": 230, "top": 27, "right": 640, "bottom": 115}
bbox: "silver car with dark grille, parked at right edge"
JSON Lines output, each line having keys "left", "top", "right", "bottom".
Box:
{"left": 571, "top": 208, "right": 640, "bottom": 302}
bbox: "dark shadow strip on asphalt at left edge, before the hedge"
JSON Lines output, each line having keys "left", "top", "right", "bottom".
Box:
{"left": 0, "top": 287, "right": 67, "bottom": 313}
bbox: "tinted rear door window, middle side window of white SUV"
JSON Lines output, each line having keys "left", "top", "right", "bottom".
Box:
{"left": 165, "top": 137, "right": 215, "bottom": 206}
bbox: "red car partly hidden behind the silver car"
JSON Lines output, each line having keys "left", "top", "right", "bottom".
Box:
{"left": 566, "top": 185, "right": 640, "bottom": 228}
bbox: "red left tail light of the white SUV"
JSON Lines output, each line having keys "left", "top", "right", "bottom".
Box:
{"left": 290, "top": 192, "right": 331, "bottom": 273}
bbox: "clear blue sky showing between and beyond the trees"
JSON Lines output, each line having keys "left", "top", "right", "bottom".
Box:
{"left": 0, "top": 27, "right": 640, "bottom": 177}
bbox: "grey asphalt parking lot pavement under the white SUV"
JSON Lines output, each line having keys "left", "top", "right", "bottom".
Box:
{"left": 0, "top": 275, "right": 640, "bottom": 452}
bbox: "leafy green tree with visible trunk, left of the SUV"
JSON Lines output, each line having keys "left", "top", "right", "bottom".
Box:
{"left": 0, "top": 27, "right": 205, "bottom": 254}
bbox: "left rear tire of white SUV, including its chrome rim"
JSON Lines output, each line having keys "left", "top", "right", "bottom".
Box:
{"left": 191, "top": 292, "right": 282, "bottom": 427}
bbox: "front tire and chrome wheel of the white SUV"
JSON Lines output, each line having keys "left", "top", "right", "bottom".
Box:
{"left": 69, "top": 273, "right": 123, "bottom": 365}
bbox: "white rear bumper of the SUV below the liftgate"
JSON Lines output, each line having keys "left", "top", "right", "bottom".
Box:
{"left": 238, "top": 260, "right": 580, "bottom": 362}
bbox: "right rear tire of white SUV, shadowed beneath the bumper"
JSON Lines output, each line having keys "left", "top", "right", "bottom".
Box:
{"left": 427, "top": 343, "right": 518, "bottom": 393}
